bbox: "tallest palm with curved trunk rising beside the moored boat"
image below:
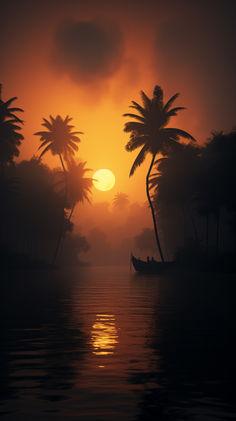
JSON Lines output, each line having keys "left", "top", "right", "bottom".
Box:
{"left": 124, "top": 86, "right": 195, "bottom": 262}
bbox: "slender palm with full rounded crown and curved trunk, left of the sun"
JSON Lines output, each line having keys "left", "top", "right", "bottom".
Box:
{"left": 35, "top": 115, "right": 82, "bottom": 263}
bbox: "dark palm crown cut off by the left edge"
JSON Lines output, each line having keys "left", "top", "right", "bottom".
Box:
{"left": 0, "top": 84, "right": 24, "bottom": 173}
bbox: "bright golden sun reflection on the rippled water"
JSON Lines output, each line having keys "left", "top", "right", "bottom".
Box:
{"left": 91, "top": 314, "right": 118, "bottom": 355}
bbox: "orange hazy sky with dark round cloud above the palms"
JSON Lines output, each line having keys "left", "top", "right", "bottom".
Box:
{"left": 0, "top": 0, "right": 236, "bottom": 200}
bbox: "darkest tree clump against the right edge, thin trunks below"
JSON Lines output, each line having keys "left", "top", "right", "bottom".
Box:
{"left": 197, "top": 129, "right": 236, "bottom": 255}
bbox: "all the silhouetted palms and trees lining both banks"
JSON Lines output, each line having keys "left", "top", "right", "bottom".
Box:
{"left": 0, "top": 86, "right": 236, "bottom": 271}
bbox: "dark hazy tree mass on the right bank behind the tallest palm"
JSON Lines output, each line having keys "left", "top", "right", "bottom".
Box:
{"left": 150, "top": 129, "right": 236, "bottom": 258}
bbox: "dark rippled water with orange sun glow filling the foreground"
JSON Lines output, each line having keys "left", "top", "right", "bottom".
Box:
{"left": 0, "top": 267, "right": 236, "bottom": 421}
